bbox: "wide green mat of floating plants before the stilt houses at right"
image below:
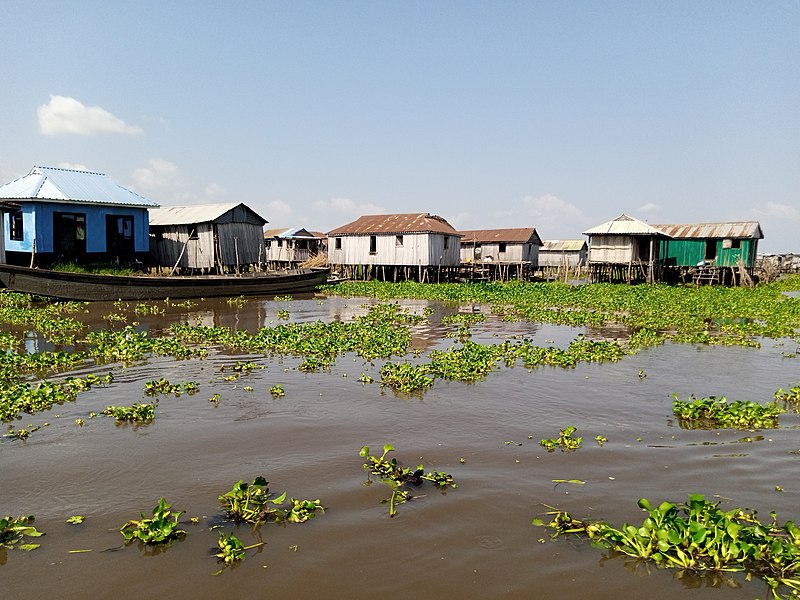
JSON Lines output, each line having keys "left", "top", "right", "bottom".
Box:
{"left": 325, "top": 276, "right": 800, "bottom": 347}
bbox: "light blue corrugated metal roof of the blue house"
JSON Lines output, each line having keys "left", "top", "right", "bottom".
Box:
{"left": 0, "top": 166, "right": 158, "bottom": 207}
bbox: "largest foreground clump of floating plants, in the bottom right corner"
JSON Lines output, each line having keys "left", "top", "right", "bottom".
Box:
{"left": 534, "top": 494, "right": 800, "bottom": 596}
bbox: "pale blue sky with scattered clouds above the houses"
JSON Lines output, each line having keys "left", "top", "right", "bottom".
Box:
{"left": 0, "top": 0, "right": 800, "bottom": 252}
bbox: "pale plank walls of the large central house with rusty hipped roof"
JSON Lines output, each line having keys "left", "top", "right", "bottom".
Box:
{"left": 328, "top": 233, "right": 460, "bottom": 266}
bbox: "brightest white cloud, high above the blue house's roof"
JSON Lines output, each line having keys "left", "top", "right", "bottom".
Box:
{"left": 36, "top": 94, "right": 144, "bottom": 135}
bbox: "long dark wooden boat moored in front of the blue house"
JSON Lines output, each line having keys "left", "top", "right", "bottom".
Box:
{"left": 0, "top": 264, "right": 330, "bottom": 301}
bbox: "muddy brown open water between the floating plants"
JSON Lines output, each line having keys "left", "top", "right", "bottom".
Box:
{"left": 0, "top": 297, "right": 800, "bottom": 600}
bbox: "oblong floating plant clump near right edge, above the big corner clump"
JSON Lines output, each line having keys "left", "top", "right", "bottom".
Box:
{"left": 672, "top": 394, "right": 784, "bottom": 429}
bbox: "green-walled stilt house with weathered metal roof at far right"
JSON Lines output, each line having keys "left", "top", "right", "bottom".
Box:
{"left": 653, "top": 221, "right": 764, "bottom": 269}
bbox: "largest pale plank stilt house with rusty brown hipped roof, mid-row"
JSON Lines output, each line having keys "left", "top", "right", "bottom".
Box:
{"left": 328, "top": 213, "right": 461, "bottom": 279}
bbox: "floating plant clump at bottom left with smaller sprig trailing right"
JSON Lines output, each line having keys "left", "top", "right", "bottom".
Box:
{"left": 219, "top": 476, "right": 325, "bottom": 525}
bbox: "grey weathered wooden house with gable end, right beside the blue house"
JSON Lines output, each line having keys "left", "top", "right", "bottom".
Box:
{"left": 150, "top": 203, "right": 267, "bottom": 273}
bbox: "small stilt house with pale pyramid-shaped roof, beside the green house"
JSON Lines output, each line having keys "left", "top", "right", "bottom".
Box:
{"left": 583, "top": 214, "right": 669, "bottom": 283}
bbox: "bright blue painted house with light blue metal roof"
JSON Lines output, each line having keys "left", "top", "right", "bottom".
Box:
{"left": 0, "top": 167, "right": 158, "bottom": 266}
